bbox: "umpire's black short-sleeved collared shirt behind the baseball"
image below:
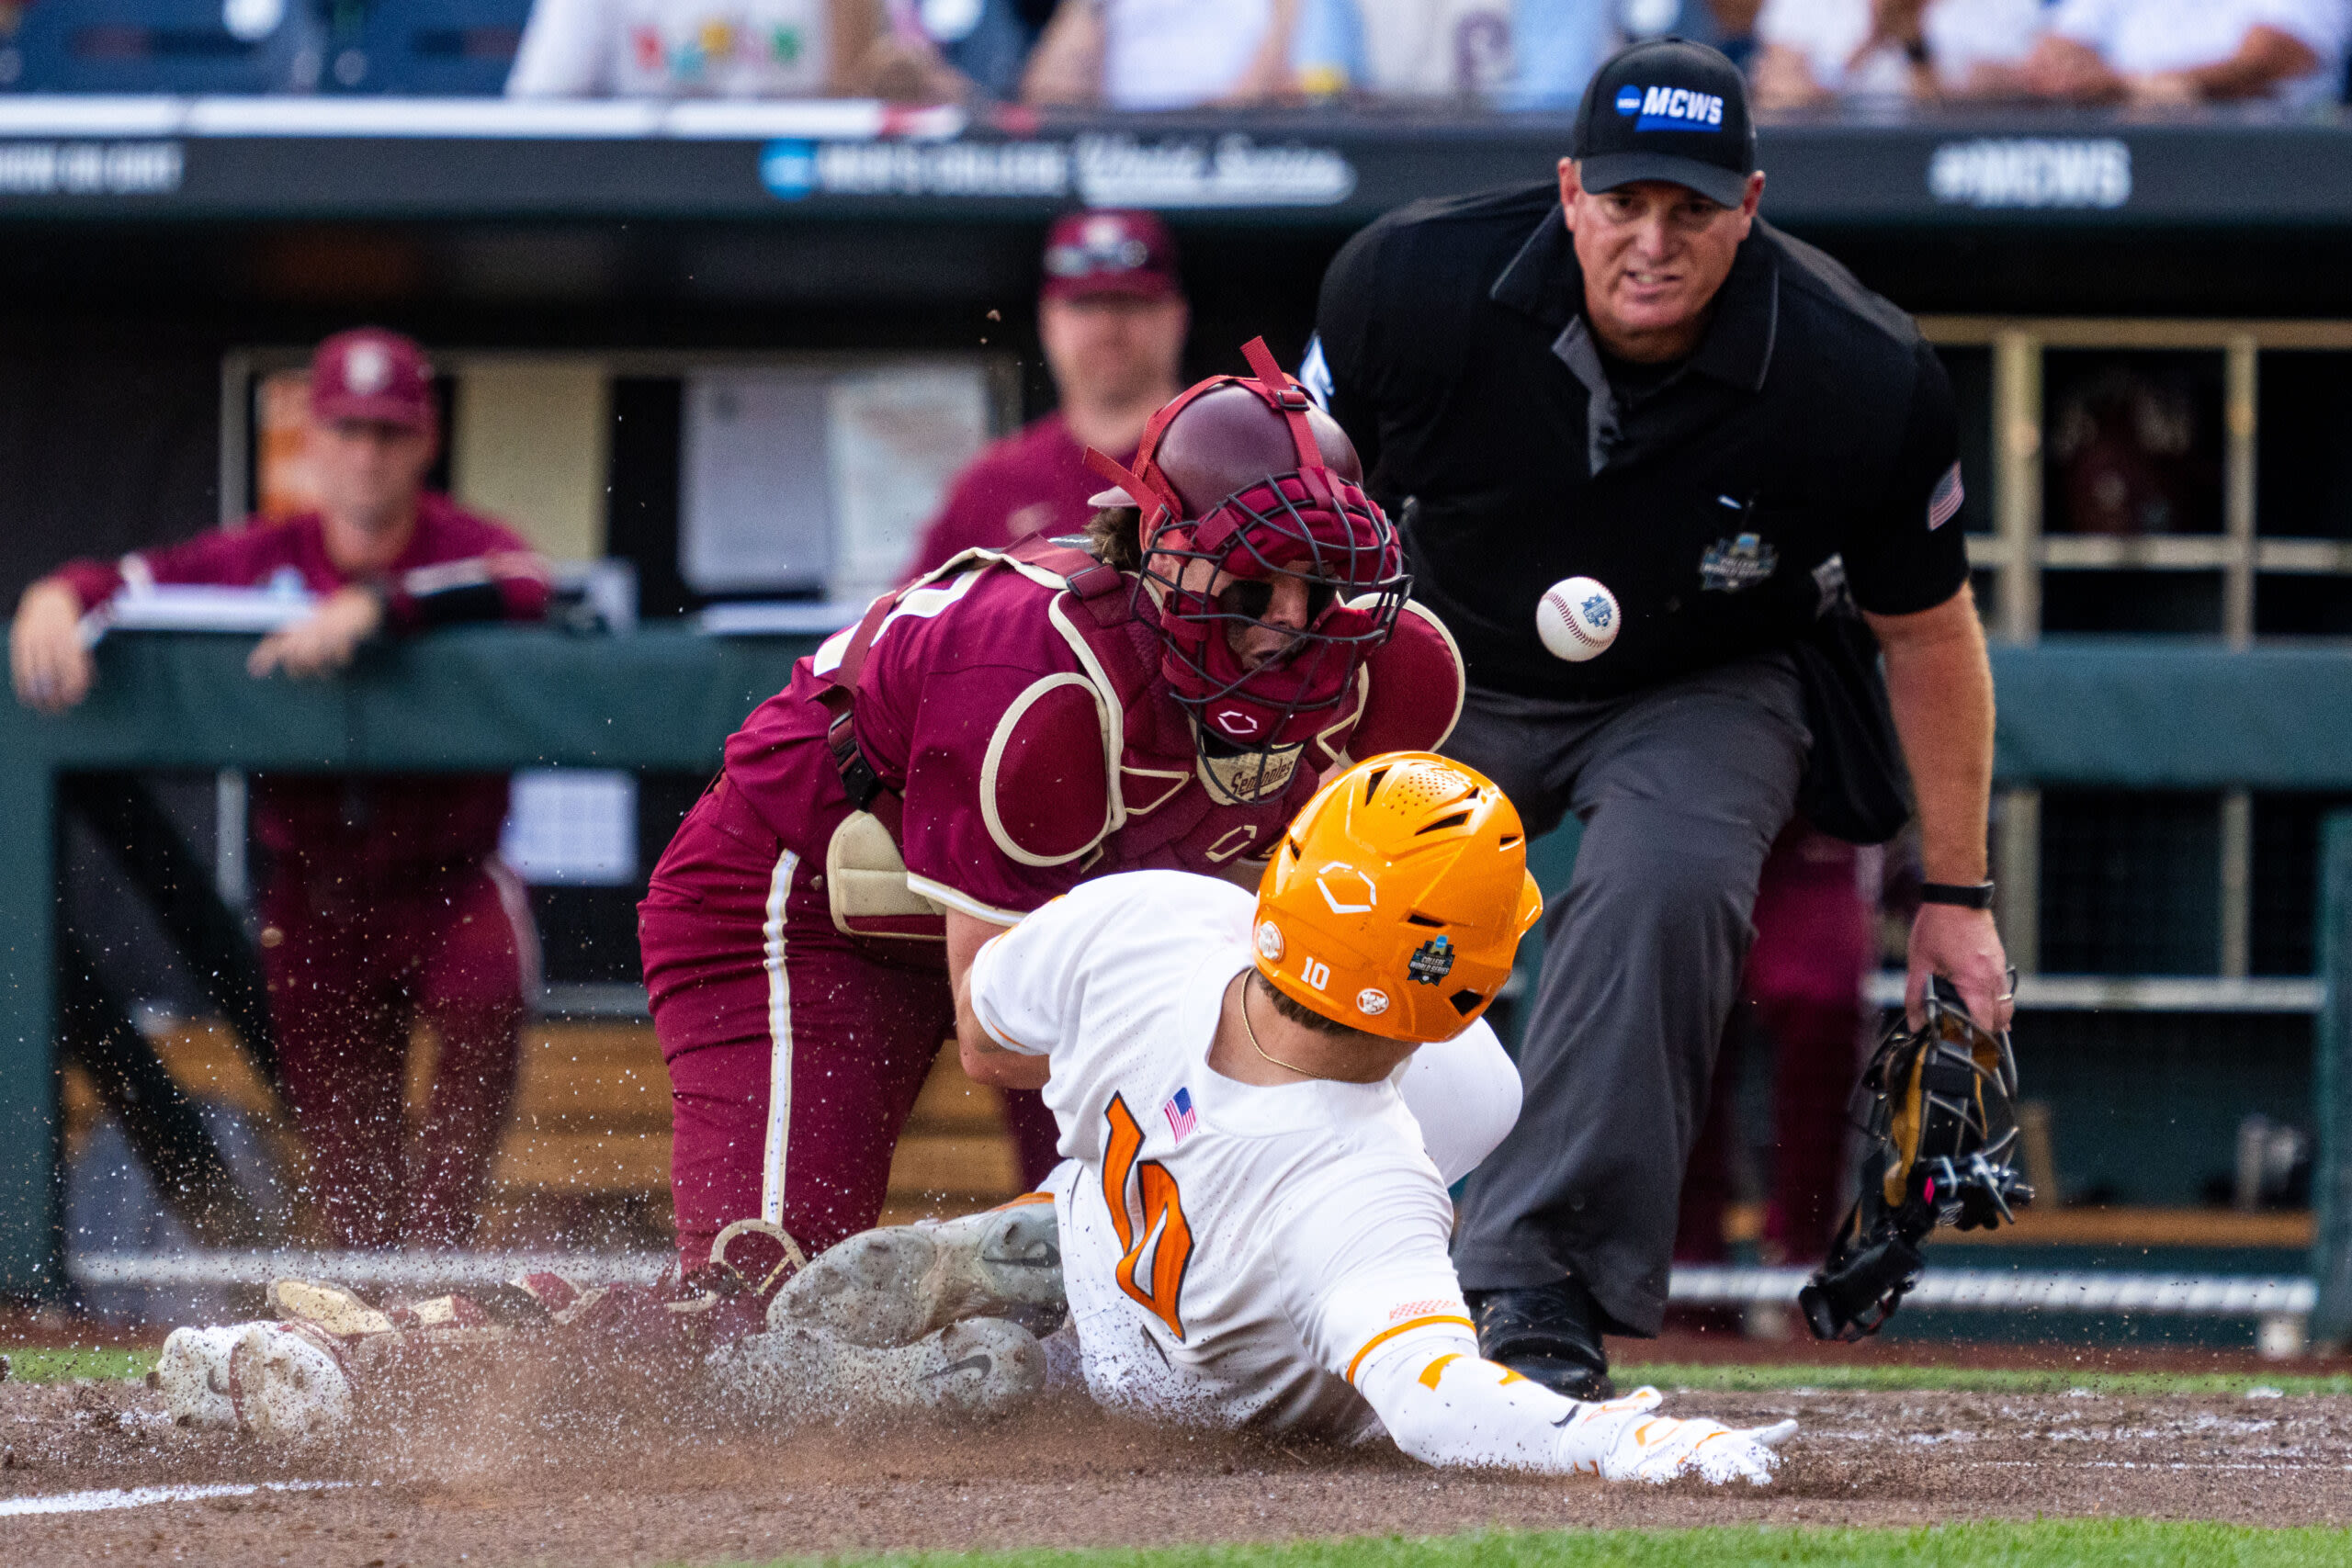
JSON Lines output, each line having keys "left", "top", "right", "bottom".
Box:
{"left": 1317, "top": 184, "right": 1969, "bottom": 698}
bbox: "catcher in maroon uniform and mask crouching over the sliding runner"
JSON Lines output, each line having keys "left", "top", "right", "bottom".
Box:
{"left": 638, "top": 344, "right": 1461, "bottom": 1277}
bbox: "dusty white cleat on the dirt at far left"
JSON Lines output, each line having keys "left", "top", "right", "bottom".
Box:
{"left": 155, "top": 1324, "right": 350, "bottom": 1438}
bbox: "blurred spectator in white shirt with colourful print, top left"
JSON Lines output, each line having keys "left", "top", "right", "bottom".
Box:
{"left": 505, "top": 0, "right": 964, "bottom": 101}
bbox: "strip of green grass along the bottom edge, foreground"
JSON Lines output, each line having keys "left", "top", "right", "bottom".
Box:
{"left": 802, "top": 1518, "right": 2352, "bottom": 1568}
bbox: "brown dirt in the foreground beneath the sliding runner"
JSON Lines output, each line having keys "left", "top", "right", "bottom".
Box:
{"left": 0, "top": 1368, "right": 2352, "bottom": 1568}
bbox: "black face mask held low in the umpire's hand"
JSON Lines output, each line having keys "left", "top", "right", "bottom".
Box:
{"left": 1797, "top": 976, "right": 2034, "bottom": 1340}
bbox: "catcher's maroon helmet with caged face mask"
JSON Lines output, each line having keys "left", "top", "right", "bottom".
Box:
{"left": 1087, "top": 339, "right": 1408, "bottom": 802}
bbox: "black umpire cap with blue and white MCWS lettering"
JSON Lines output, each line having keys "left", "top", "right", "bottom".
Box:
{"left": 1576, "top": 38, "right": 1757, "bottom": 207}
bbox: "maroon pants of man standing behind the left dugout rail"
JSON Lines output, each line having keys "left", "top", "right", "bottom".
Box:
{"left": 261, "top": 861, "right": 538, "bottom": 1248}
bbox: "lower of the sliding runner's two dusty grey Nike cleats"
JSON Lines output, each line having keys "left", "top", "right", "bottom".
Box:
{"left": 710, "top": 1316, "right": 1045, "bottom": 1417}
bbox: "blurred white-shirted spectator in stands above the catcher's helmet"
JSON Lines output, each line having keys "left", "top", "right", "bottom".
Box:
{"left": 1021, "top": 0, "right": 1303, "bottom": 108}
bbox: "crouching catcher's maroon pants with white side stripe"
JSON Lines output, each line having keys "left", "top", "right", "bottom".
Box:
{"left": 638, "top": 781, "right": 1056, "bottom": 1274}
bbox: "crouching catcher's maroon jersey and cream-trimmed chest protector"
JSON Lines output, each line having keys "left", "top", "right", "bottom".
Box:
{"left": 727, "top": 552, "right": 1463, "bottom": 924}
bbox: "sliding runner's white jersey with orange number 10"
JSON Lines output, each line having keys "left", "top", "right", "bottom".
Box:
{"left": 971, "top": 872, "right": 1520, "bottom": 1438}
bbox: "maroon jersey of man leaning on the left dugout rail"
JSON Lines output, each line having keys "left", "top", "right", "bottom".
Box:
{"left": 54, "top": 493, "right": 548, "bottom": 886}
